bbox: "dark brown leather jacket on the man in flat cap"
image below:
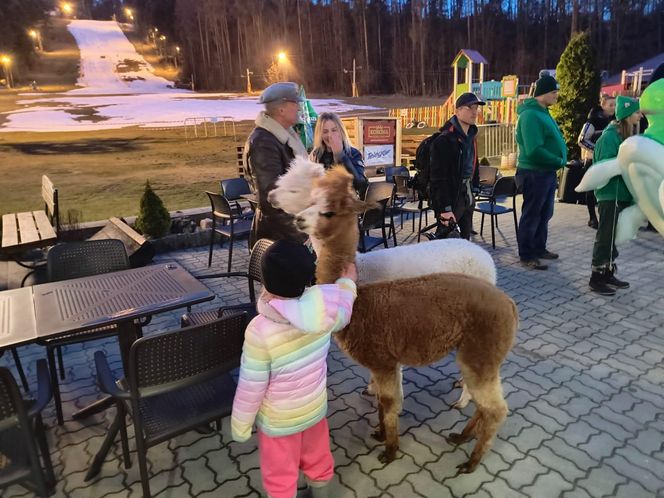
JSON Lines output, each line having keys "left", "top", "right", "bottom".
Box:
{"left": 245, "top": 127, "right": 307, "bottom": 245}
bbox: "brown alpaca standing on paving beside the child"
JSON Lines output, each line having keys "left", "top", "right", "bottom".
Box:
{"left": 297, "top": 166, "right": 519, "bottom": 472}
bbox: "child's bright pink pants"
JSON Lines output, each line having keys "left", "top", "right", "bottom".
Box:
{"left": 258, "top": 418, "right": 334, "bottom": 498}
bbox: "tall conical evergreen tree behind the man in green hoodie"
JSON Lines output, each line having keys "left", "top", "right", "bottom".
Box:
{"left": 551, "top": 33, "right": 601, "bottom": 159}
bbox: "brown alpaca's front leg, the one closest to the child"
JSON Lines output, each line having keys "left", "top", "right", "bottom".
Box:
{"left": 374, "top": 365, "right": 400, "bottom": 463}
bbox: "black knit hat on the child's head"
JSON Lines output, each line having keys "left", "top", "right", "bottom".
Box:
{"left": 261, "top": 240, "right": 316, "bottom": 297}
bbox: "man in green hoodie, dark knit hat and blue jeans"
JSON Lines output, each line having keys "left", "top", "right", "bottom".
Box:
{"left": 516, "top": 73, "right": 567, "bottom": 270}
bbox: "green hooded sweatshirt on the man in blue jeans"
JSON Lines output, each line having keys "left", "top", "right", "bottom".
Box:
{"left": 516, "top": 98, "right": 567, "bottom": 171}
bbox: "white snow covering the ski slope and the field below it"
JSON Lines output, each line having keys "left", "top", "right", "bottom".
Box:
{"left": 0, "top": 20, "right": 375, "bottom": 132}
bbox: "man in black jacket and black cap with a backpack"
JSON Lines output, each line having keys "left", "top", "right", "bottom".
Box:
{"left": 429, "top": 93, "right": 485, "bottom": 239}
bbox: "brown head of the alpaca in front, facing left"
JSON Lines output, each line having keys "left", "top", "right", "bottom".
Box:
{"left": 295, "top": 166, "right": 366, "bottom": 240}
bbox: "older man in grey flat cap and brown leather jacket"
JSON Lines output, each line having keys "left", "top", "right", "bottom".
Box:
{"left": 244, "top": 82, "right": 307, "bottom": 249}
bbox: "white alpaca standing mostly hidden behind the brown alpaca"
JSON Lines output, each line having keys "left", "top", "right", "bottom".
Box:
{"left": 268, "top": 157, "right": 496, "bottom": 409}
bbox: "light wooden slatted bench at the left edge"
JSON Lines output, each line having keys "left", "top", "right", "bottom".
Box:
{"left": 2, "top": 175, "right": 60, "bottom": 260}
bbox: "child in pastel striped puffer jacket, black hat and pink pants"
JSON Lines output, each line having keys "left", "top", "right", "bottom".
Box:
{"left": 231, "top": 240, "right": 357, "bottom": 498}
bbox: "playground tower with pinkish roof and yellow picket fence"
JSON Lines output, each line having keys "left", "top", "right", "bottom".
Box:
{"left": 390, "top": 48, "right": 526, "bottom": 129}
